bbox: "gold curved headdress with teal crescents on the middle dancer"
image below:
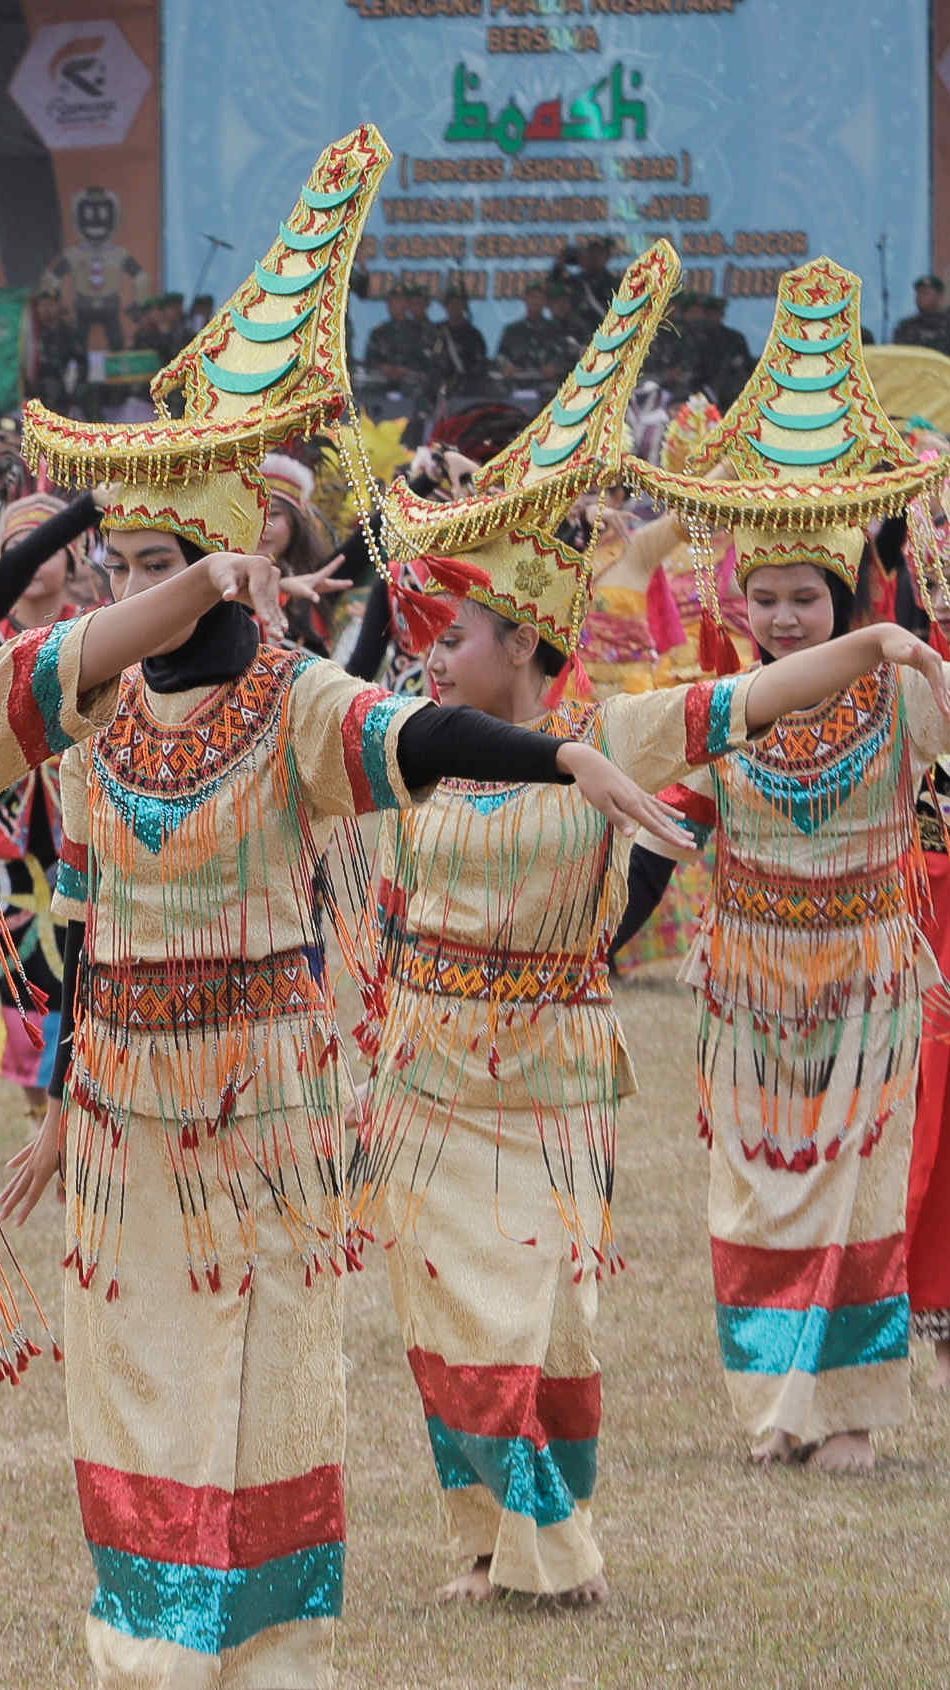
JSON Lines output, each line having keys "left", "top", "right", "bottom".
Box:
{"left": 370, "top": 240, "right": 680, "bottom": 684}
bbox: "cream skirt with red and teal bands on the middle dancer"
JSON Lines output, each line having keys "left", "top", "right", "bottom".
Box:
{"left": 380, "top": 1092, "right": 602, "bottom": 1594}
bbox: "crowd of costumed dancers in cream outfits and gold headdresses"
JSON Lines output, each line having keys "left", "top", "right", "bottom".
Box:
{"left": 0, "top": 125, "right": 950, "bottom": 1690}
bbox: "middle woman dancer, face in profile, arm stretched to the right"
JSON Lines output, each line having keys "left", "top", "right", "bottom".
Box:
{"left": 352, "top": 245, "right": 945, "bottom": 1604}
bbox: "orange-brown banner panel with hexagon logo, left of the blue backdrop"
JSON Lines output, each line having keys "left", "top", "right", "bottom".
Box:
{"left": 0, "top": 0, "right": 161, "bottom": 332}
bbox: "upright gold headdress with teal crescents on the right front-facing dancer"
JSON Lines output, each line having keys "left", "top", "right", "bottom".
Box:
{"left": 637, "top": 259, "right": 950, "bottom": 668}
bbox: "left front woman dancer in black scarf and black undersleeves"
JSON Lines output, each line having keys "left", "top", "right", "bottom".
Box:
{"left": 0, "top": 128, "right": 679, "bottom": 1690}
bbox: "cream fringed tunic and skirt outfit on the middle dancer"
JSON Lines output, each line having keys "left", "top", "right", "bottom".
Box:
{"left": 352, "top": 678, "right": 751, "bottom": 1594}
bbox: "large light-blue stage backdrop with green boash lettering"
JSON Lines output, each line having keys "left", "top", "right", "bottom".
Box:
{"left": 164, "top": 0, "right": 931, "bottom": 348}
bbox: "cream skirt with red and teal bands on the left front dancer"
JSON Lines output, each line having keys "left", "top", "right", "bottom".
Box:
{"left": 66, "top": 1105, "right": 345, "bottom": 1690}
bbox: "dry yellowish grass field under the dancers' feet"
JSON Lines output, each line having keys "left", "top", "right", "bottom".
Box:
{"left": 0, "top": 970, "right": 950, "bottom": 1690}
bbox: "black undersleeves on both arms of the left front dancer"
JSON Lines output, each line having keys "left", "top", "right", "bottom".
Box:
{"left": 49, "top": 705, "right": 573, "bottom": 1097}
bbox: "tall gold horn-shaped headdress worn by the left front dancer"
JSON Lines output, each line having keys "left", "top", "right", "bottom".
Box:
{"left": 24, "top": 123, "right": 390, "bottom": 551}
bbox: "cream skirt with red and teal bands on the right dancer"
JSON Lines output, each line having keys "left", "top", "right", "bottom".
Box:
{"left": 700, "top": 997, "right": 921, "bottom": 1443}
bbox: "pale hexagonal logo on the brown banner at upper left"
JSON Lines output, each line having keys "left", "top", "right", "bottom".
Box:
{"left": 10, "top": 19, "right": 152, "bottom": 152}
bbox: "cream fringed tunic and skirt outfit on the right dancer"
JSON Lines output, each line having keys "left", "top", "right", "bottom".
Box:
{"left": 641, "top": 666, "right": 950, "bottom": 1443}
